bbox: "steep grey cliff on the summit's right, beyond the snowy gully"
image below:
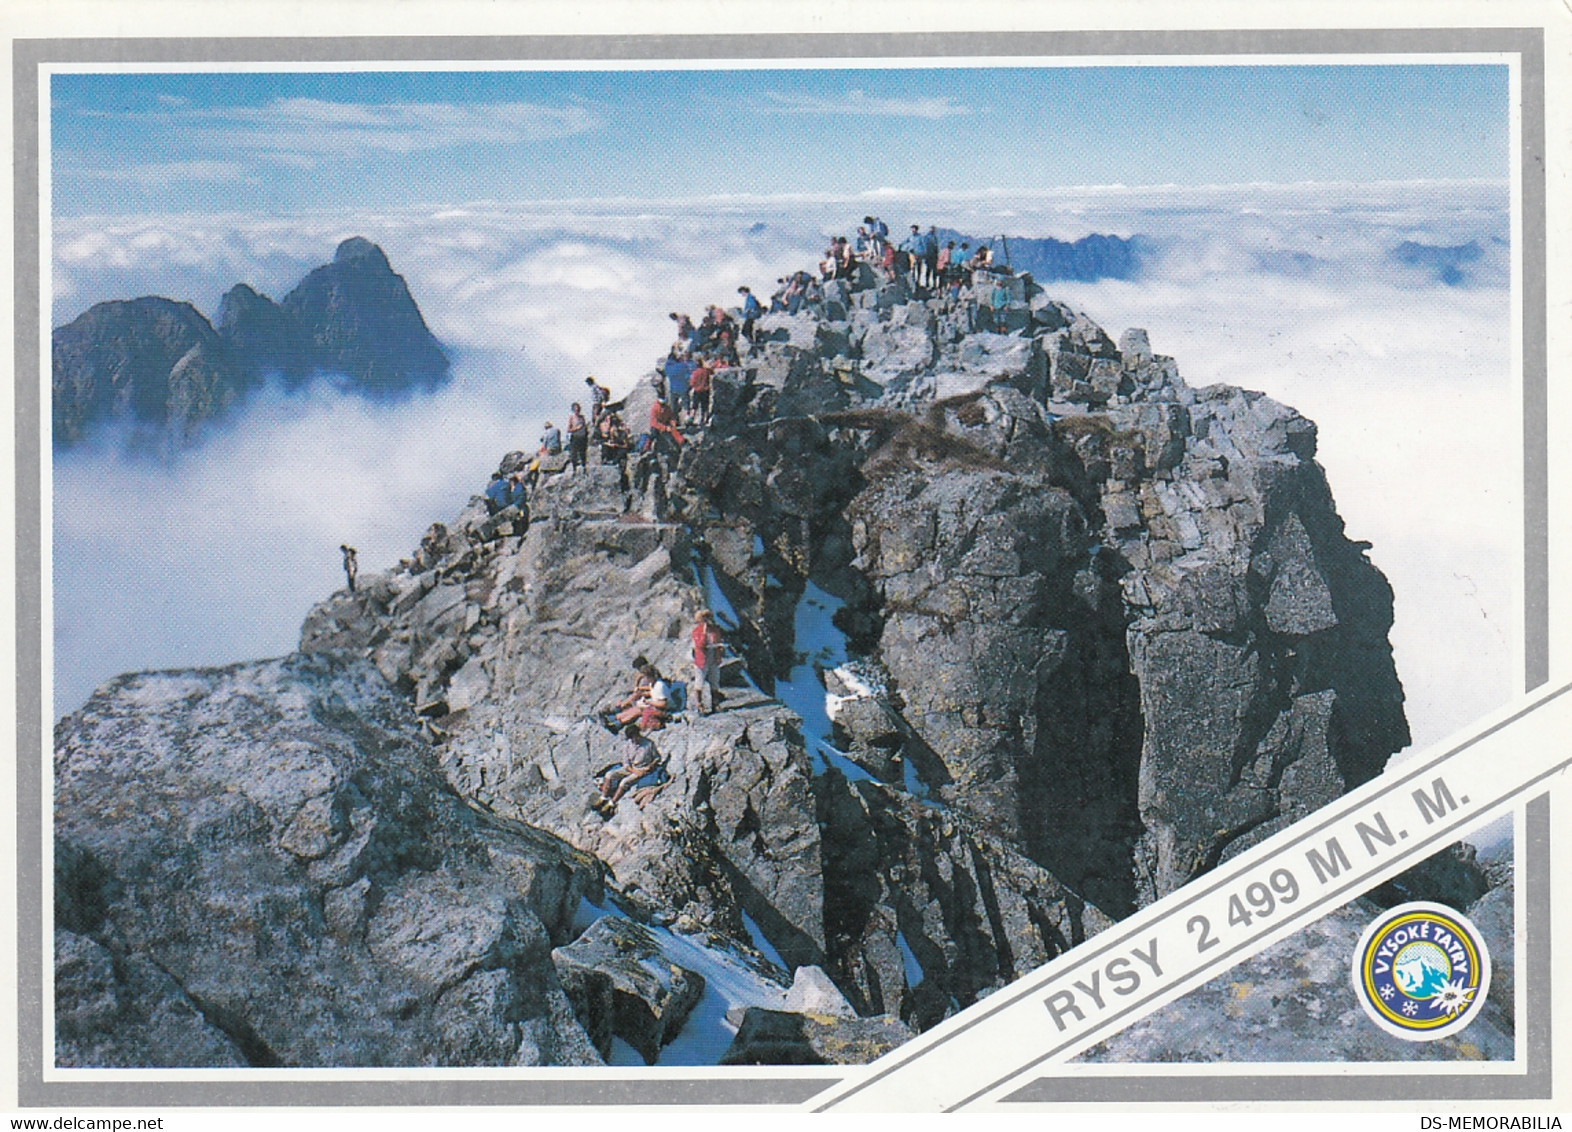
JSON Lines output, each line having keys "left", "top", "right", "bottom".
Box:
{"left": 669, "top": 277, "right": 1409, "bottom": 913}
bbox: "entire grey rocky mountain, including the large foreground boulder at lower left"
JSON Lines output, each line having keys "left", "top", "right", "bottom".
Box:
{"left": 55, "top": 249, "right": 1439, "bottom": 1064}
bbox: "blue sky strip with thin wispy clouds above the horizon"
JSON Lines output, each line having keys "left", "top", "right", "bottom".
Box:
{"left": 50, "top": 64, "right": 1509, "bottom": 217}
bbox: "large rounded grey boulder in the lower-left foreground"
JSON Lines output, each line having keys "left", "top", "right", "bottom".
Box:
{"left": 55, "top": 656, "right": 601, "bottom": 1066}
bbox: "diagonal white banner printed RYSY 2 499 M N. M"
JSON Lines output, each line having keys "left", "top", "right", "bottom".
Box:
{"left": 811, "top": 684, "right": 1572, "bottom": 1112}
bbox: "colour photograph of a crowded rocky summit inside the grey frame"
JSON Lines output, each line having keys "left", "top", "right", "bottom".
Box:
{"left": 44, "top": 60, "right": 1522, "bottom": 1069}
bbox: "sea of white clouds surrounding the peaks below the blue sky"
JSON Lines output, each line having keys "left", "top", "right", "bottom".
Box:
{"left": 52, "top": 184, "right": 1522, "bottom": 760}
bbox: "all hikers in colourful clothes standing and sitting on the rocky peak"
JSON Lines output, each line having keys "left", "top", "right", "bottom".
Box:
{"left": 455, "top": 215, "right": 1012, "bottom": 818}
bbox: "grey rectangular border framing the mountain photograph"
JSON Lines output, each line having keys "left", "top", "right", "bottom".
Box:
{"left": 13, "top": 27, "right": 1550, "bottom": 1107}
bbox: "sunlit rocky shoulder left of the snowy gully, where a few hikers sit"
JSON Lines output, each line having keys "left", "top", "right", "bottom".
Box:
{"left": 302, "top": 469, "right": 1108, "bottom": 1025}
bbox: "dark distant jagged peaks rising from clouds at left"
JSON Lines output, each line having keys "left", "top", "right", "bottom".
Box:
{"left": 52, "top": 236, "right": 448, "bottom": 447}
